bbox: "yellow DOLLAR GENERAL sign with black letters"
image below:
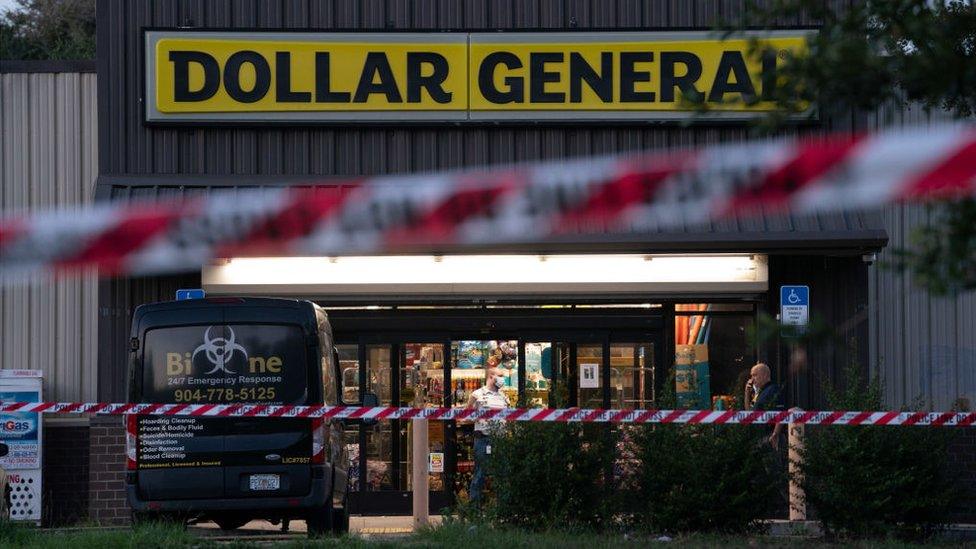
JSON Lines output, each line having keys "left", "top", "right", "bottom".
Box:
{"left": 146, "top": 31, "right": 804, "bottom": 123}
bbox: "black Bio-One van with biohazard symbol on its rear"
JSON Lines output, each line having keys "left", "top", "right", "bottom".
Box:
{"left": 126, "top": 298, "right": 349, "bottom": 534}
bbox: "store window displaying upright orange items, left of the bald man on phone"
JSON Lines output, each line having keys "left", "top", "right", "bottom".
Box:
{"left": 674, "top": 303, "right": 756, "bottom": 410}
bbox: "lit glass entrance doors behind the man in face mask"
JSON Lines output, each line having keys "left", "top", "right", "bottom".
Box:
{"left": 338, "top": 332, "right": 662, "bottom": 514}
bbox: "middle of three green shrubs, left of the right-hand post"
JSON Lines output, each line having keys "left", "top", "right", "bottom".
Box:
{"left": 626, "top": 425, "right": 786, "bottom": 533}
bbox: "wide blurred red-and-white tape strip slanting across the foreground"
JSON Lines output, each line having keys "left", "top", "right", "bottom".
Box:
{"left": 0, "top": 124, "right": 976, "bottom": 283}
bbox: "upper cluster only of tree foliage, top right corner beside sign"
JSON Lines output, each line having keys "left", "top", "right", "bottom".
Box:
{"left": 724, "top": 0, "right": 976, "bottom": 117}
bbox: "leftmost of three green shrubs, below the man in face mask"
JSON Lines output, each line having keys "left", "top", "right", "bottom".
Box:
{"left": 485, "top": 423, "right": 614, "bottom": 530}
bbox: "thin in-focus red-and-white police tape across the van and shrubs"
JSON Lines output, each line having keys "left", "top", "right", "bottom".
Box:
{"left": 0, "top": 402, "right": 976, "bottom": 427}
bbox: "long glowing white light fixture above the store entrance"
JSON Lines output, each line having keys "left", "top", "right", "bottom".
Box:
{"left": 203, "top": 254, "right": 767, "bottom": 295}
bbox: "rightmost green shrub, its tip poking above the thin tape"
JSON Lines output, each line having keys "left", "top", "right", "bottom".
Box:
{"left": 801, "top": 365, "right": 958, "bottom": 539}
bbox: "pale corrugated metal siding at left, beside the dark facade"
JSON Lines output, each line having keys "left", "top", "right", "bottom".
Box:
{"left": 0, "top": 73, "right": 98, "bottom": 400}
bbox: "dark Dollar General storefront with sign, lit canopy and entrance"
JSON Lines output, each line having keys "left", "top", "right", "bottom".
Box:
{"left": 96, "top": 0, "right": 887, "bottom": 513}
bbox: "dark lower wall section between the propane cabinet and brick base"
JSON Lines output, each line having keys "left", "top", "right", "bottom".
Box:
{"left": 41, "top": 419, "right": 89, "bottom": 526}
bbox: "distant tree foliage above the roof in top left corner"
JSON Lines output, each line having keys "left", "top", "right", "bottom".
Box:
{"left": 0, "top": 0, "right": 95, "bottom": 60}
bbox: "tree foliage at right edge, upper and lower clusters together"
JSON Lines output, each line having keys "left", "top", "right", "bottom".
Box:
{"left": 722, "top": 0, "right": 976, "bottom": 294}
